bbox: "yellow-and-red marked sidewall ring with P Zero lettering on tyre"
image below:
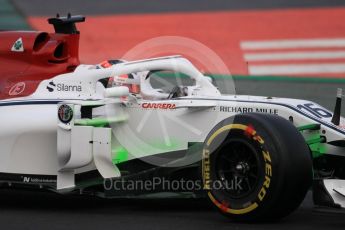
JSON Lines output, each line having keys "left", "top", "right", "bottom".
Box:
{"left": 202, "top": 124, "right": 272, "bottom": 214}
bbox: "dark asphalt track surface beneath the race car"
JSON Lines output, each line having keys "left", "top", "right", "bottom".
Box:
{"left": 0, "top": 190, "right": 345, "bottom": 230}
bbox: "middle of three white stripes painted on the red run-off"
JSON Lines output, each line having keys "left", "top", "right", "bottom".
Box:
{"left": 244, "top": 51, "right": 345, "bottom": 61}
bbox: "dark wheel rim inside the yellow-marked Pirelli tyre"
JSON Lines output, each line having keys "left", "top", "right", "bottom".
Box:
{"left": 216, "top": 139, "right": 259, "bottom": 199}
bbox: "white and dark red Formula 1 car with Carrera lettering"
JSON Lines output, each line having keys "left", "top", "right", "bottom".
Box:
{"left": 0, "top": 16, "right": 345, "bottom": 221}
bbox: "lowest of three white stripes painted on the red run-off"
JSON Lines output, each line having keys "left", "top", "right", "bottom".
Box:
{"left": 248, "top": 63, "right": 345, "bottom": 75}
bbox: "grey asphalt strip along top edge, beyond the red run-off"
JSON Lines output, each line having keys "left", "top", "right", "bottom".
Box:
{"left": 13, "top": 0, "right": 345, "bottom": 16}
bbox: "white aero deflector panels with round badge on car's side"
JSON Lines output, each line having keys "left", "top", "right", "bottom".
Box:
{"left": 57, "top": 104, "right": 121, "bottom": 192}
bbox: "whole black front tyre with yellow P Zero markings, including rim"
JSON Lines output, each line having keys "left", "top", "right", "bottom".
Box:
{"left": 202, "top": 113, "right": 312, "bottom": 221}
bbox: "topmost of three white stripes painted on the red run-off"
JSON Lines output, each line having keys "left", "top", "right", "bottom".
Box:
{"left": 240, "top": 38, "right": 345, "bottom": 50}
